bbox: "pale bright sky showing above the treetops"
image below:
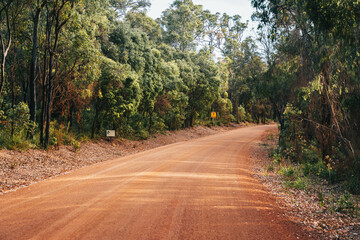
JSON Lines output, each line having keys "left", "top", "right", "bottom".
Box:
{"left": 147, "top": 0, "right": 257, "bottom": 36}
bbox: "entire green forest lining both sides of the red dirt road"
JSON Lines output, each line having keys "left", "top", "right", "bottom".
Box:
{"left": 0, "top": 0, "right": 360, "bottom": 193}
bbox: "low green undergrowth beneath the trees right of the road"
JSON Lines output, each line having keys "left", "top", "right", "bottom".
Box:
{"left": 266, "top": 132, "right": 360, "bottom": 217}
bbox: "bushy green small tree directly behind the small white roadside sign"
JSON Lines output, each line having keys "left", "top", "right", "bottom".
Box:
{"left": 92, "top": 58, "right": 141, "bottom": 135}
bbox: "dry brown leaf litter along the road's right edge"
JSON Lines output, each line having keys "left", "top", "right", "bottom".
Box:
{"left": 252, "top": 129, "right": 360, "bottom": 240}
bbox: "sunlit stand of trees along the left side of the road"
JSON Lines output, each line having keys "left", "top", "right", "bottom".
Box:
{"left": 0, "top": 0, "right": 273, "bottom": 149}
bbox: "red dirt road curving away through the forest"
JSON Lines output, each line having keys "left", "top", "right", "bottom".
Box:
{"left": 0, "top": 125, "right": 308, "bottom": 240}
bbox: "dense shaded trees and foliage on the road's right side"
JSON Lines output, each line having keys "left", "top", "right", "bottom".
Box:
{"left": 252, "top": 0, "right": 360, "bottom": 195}
